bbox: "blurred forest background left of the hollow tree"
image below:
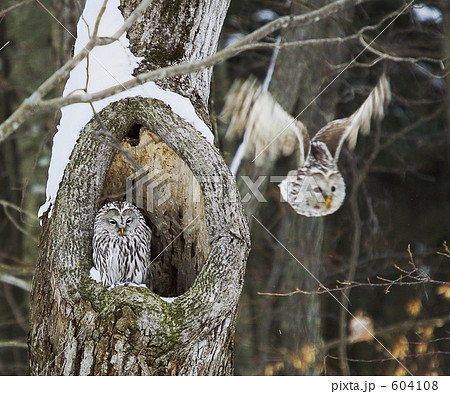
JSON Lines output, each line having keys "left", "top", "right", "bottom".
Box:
{"left": 0, "top": 0, "right": 83, "bottom": 375}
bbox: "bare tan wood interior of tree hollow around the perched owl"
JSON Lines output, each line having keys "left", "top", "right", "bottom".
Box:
{"left": 103, "top": 124, "right": 209, "bottom": 297}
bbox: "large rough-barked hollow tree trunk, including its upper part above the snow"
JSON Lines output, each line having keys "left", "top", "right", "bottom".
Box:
{"left": 28, "top": 0, "right": 250, "bottom": 375}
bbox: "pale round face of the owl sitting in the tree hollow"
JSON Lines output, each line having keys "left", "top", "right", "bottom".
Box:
{"left": 98, "top": 203, "right": 139, "bottom": 237}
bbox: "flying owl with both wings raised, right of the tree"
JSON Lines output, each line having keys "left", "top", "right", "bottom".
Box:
{"left": 223, "top": 74, "right": 391, "bottom": 217}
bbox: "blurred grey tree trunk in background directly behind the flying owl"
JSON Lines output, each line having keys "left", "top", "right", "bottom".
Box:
{"left": 270, "top": 0, "right": 344, "bottom": 375}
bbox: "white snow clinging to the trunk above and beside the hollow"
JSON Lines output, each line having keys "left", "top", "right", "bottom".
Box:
{"left": 38, "top": 0, "right": 214, "bottom": 217}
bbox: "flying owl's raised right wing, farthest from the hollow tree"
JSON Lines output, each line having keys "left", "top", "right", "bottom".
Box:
{"left": 313, "top": 74, "right": 391, "bottom": 160}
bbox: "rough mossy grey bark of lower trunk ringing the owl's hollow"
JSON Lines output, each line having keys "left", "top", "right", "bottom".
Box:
{"left": 29, "top": 98, "right": 249, "bottom": 374}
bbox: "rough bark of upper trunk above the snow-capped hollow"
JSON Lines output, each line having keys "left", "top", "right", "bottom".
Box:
{"left": 121, "top": 0, "right": 230, "bottom": 124}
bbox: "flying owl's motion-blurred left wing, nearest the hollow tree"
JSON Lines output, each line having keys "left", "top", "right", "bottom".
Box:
{"left": 221, "top": 79, "right": 309, "bottom": 165}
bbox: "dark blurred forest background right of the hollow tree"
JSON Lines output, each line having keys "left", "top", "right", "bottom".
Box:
{"left": 215, "top": 0, "right": 450, "bottom": 375}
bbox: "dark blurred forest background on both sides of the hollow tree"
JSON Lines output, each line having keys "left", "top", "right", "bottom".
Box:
{"left": 0, "top": 0, "right": 450, "bottom": 375}
